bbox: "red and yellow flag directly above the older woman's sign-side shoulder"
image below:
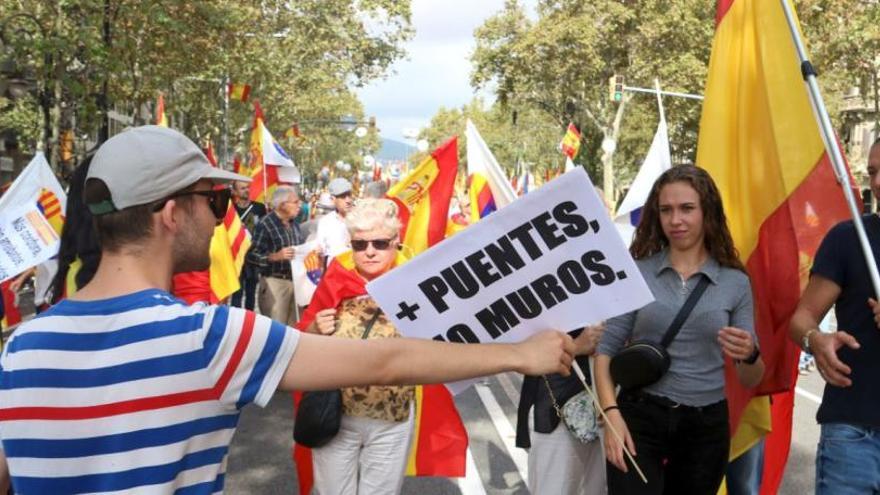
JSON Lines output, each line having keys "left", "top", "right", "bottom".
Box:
{"left": 388, "top": 137, "right": 458, "bottom": 255}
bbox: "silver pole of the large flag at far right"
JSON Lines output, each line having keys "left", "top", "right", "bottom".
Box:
{"left": 780, "top": 0, "right": 880, "bottom": 297}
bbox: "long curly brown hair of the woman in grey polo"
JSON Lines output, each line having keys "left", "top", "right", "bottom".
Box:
{"left": 629, "top": 165, "right": 746, "bottom": 272}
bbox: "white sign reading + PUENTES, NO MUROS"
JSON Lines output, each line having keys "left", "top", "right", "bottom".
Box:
{"left": 367, "top": 167, "right": 654, "bottom": 394}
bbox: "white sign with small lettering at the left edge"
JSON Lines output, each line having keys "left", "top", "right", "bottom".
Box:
{"left": 0, "top": 203, "right": 61, "bottom": 282}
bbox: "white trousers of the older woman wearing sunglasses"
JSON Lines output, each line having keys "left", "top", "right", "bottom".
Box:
{"left": 312, "top": 409, "right": 414, "bottom": 495}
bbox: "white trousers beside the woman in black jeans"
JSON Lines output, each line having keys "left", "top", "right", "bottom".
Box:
{"left": 529, "top": 412, "right": 608, "bottom": 495}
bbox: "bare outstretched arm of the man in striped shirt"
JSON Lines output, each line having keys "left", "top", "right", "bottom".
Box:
{"left": 279, "top": 331, "right": 574, "bottom": 390}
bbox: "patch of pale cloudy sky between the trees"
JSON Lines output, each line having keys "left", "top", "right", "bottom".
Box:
{"left": 358, "top": 0, "right": 532, "bottom": 144}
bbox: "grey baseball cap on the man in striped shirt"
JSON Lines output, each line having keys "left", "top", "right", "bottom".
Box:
{"left": 86, "top": 125, "right": 251, "bottom": 215}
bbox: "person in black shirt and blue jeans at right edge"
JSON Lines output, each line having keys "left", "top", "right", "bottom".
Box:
{"left": 789, "top": 140, "right": 880, "bottom": 495}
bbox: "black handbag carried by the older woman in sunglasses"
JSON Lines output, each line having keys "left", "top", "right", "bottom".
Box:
{"left": 293, "top": 309, "right": 382, "bottom": 449}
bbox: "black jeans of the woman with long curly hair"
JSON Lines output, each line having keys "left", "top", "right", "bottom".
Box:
{"left": 607, "top": 392, "right": 730, "bottom": 495}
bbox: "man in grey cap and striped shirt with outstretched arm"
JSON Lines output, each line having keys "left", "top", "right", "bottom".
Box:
{"left": 0, "top": 126, "right": 573, "bottom": 493}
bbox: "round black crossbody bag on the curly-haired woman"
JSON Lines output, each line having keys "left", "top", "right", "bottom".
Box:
{"left": 611, "top": 275, "right": 709, "bottom": 390}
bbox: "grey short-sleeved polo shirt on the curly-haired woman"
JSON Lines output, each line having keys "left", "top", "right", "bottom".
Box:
{"left": 597, "top": 250, "right": 757, "bottom": 406}
